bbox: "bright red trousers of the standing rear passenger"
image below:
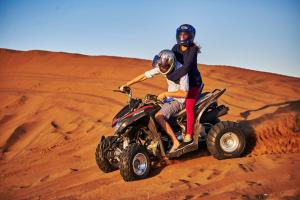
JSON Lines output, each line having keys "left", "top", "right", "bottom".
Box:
{"left": 185, "top": 86, "right": 203, "bottom": 135}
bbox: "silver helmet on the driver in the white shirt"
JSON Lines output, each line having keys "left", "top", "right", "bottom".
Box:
{"left": 152, "top": 49, "right": 176, "bottom": 75}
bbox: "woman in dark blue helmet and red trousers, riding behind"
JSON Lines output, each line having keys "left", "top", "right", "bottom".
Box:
{"left": 167, "top": 24, "right": 203, "bottom": 148}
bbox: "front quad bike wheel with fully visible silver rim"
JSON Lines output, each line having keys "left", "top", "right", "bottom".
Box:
{"left": 120, "top": 143, "right": 151, "bottom": 181}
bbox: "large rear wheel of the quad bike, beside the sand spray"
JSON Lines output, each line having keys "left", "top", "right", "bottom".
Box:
{"left": 206, "top": 121, "right": 246, "bottom": 160}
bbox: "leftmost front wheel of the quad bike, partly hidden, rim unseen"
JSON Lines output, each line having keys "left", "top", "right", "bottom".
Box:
{"left": 95, "top": 136, "right": 117, "bottom": 173}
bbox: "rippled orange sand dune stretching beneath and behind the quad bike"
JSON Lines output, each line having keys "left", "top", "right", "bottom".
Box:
{"left": 0, "top": 49, "right": 300, "bottom": 199}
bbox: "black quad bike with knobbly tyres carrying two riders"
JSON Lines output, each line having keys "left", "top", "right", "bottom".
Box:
{"left": 95, "top": 87, "right": 246, "bottom": 181}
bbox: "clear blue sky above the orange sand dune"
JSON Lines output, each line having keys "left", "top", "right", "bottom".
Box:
{"left": 0, "top": 0, "right": 300, "bottom": 77}
